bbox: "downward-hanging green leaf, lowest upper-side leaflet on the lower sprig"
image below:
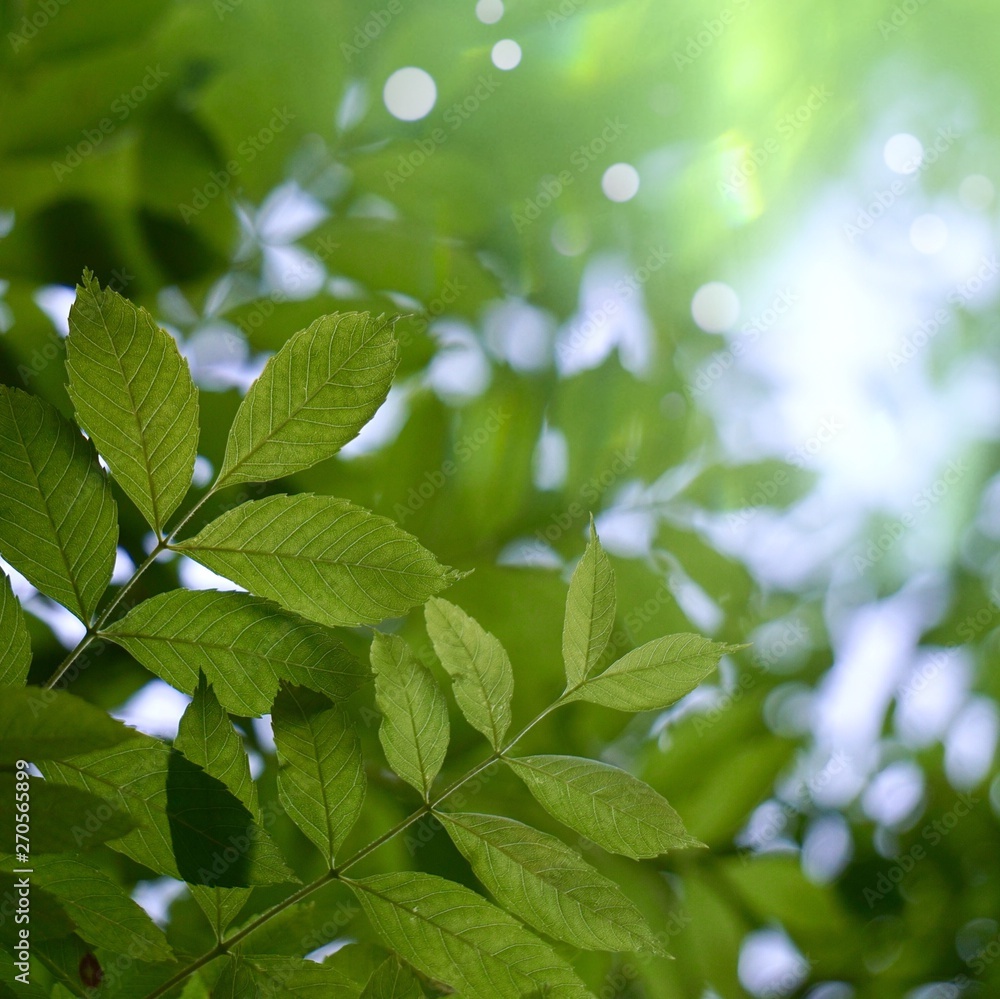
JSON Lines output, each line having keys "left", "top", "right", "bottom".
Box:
{"left": 271, "top": 686, "right": 365, "bottom": 868}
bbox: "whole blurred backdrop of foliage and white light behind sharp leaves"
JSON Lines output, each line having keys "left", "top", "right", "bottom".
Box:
{"left": 0, "top": 0, "right": 1000, "bottom": 999}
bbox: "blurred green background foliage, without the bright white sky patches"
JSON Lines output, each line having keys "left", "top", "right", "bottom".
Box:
{"left": 0, "top": 0, "right": 1000, "bottom": 999}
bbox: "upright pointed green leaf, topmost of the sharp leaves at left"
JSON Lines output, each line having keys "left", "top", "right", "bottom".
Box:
{"left": 66, "top": 271, "right": 198, "bottom": 533}
